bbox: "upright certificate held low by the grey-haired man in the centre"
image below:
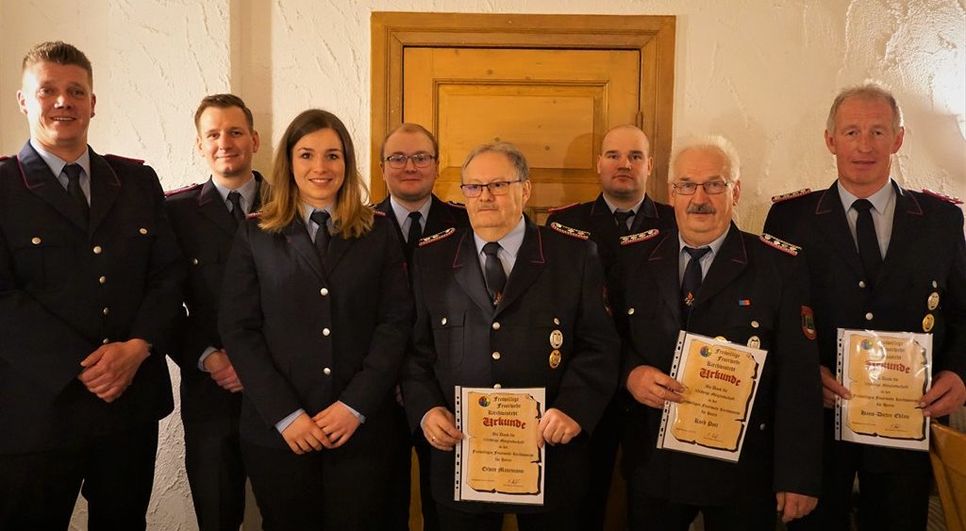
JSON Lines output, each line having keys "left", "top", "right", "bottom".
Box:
{"left": 453, "top": 387, "right": 546, "bottom": 505}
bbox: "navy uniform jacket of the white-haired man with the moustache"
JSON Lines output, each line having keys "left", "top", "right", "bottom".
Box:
{"left": 620, "top": 224, "right": 822, "bottom": 505}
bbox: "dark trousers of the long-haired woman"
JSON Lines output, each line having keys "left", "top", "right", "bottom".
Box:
{"left": 241, "top": 436, "right": 395, "bottom": 531}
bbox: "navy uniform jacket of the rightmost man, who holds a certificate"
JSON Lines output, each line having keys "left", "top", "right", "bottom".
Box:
{"left": 765, "top": 183, "right": 966, "bottom": 471}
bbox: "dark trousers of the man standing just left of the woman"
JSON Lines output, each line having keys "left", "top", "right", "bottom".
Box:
{"left": 184, "top": 416, "right": 245, "bottom": 531}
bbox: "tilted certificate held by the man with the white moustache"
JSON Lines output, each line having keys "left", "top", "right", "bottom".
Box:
{"left": 657, "top": 330, "right": 768, "bottom": 462}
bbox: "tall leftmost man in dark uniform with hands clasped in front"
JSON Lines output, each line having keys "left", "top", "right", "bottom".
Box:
{"left": 0, "top": 42, "right": 184, "bottom": 529}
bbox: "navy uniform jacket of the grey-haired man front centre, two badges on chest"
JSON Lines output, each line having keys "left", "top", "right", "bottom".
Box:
{"left": 402, "top": 220, "right": 619, "bottom": 512}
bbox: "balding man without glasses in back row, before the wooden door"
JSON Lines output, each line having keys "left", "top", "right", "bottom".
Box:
{"left": 547, "top": 125, "right": 674, "bottom": 531}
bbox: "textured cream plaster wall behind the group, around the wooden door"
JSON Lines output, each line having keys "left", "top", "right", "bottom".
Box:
{"left": 0, "top": 0, "right": 966, "bottom": 529}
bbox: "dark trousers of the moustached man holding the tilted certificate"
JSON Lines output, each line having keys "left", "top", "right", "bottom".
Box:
{"left": 627, "top": 485, "right": 777, "bottom": 531}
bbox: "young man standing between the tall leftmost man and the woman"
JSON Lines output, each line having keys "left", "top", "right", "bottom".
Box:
{"left": 165, "top": 94, "right": 262, "bottom": 530}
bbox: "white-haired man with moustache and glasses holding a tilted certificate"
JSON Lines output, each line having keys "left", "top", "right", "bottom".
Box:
{"left": 619, "top": 137, "right": 822, "bottom": 531}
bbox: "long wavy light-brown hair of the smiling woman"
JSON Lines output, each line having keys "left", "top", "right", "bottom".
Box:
{"left": 258, "top": 109, "right": 374, "bottom": 238}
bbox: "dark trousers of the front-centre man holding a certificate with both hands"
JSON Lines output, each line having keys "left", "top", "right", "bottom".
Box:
{"left": 436, "top": 504, "right": 582, "bottom": 531}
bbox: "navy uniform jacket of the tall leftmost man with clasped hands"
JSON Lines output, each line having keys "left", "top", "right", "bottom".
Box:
{"left": 0, "top": 143, "right": 184, "bottom": 453}
